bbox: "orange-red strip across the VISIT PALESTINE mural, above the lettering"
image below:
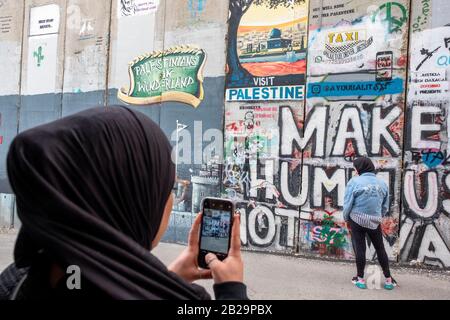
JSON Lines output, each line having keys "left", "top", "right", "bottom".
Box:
{"left": 242, "top": 60, "right": 306, "bottom": 77}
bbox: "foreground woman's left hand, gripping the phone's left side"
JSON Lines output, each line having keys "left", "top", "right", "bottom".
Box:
{"left": 168, "top": 214, "right": 212, "bottom": 282}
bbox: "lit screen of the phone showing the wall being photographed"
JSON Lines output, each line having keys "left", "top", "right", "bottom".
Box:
{"left": 200, "top": 208, "right": 231, "bottom": 254}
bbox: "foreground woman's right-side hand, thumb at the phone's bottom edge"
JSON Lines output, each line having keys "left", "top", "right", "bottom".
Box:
{"left": 205, "top": 214, "right": 244, "bottom": 284}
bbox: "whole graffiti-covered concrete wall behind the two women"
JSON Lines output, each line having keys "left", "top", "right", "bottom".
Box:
{"left": 0, "top": 0, "right": 450, "bottom": 268}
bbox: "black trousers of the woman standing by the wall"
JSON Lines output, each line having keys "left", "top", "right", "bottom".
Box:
{"left": 349, "top": 219, "right": 391, "bottom": 278}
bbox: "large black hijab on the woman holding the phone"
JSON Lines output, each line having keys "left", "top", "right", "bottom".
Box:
{"left": 7, "top": 107, "right": 209, "bottom": 299}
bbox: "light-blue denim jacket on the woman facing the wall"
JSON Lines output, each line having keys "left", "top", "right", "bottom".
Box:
{"left": 343, "top": 173, "right": 389, "bottom": 221}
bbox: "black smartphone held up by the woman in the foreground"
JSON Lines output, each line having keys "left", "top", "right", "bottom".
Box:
{"left": 198, "top": 198, "right": 234, "bottom": 269}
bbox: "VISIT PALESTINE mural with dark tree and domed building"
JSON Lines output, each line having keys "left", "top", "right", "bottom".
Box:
{"left": 226, "top": 0, "right": 308, "bottom": 101}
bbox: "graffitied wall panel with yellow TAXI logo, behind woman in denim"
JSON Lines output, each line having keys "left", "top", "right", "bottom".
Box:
{"left": 299, "top": 1, "right": 408, "bottom": 259}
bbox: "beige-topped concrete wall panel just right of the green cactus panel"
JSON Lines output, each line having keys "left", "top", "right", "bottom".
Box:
{"left": 62, "top": 0, "right": 112, "bottom": 116}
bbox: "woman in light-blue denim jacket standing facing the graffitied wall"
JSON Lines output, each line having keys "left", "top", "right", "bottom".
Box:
{"left": 343, "top": 157, "right": 396, "bottom": 290}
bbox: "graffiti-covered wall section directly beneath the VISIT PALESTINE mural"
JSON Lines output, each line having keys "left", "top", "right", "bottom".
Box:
{"left": 223, "top": 102, "right": 303, "bottom": 250}
